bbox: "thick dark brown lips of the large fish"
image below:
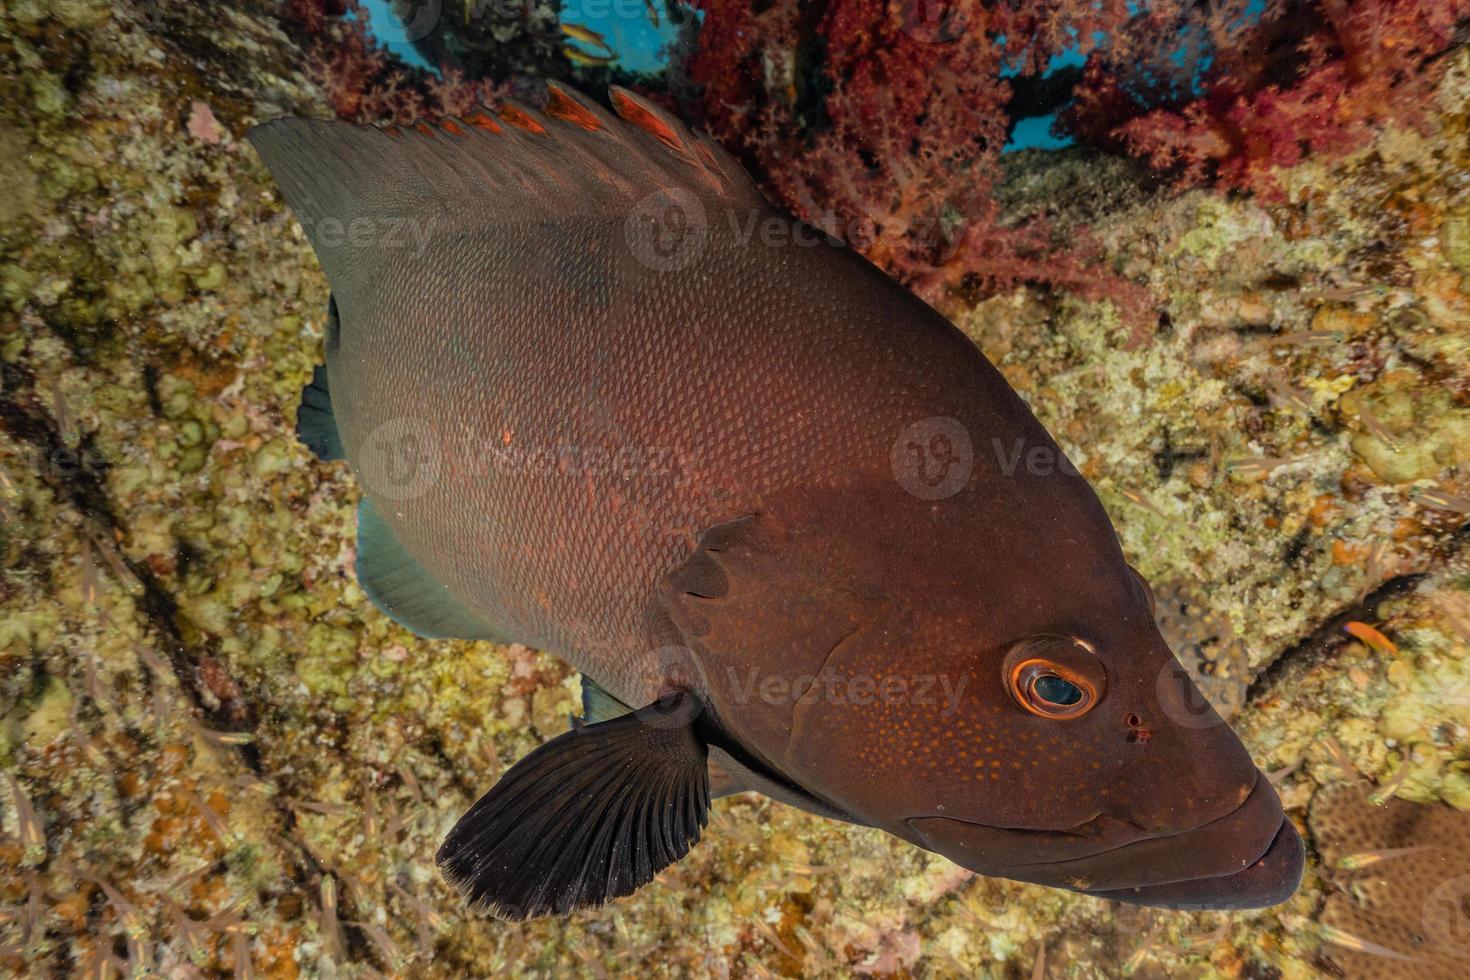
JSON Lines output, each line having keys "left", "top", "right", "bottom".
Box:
{"left": 907, "top": 774, "right": 1305, "bottom": 908}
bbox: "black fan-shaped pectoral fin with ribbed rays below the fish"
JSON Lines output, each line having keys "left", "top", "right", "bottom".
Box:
{"left": 438, "top": 696, "right": 710, "bottom": 920}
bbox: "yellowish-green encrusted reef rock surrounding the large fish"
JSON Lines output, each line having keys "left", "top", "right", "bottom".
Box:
{"left": 0, "top": 0, "right": 1470, "bottom": 980}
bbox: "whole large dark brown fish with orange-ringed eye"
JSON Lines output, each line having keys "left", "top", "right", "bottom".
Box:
{"left": 250, "top": 85, "right": 1302, "bottom": 917}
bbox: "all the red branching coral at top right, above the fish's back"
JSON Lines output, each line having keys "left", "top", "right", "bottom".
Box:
{"left": 689, "top": 0, "right": 1470, "bottom": 323}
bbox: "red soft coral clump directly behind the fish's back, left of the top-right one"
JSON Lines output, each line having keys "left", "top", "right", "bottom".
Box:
{"left": 689, "top": 0, "right": 1150, "bottom": 322}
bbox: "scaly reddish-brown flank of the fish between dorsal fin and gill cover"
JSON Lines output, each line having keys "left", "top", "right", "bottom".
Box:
{"left": 317, "top": 137, "right": 1050, "bottom": 704}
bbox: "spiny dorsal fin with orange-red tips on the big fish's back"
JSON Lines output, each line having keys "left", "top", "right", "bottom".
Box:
{"left": 250, "top": 85, "right": 767, "bottom": 291}
